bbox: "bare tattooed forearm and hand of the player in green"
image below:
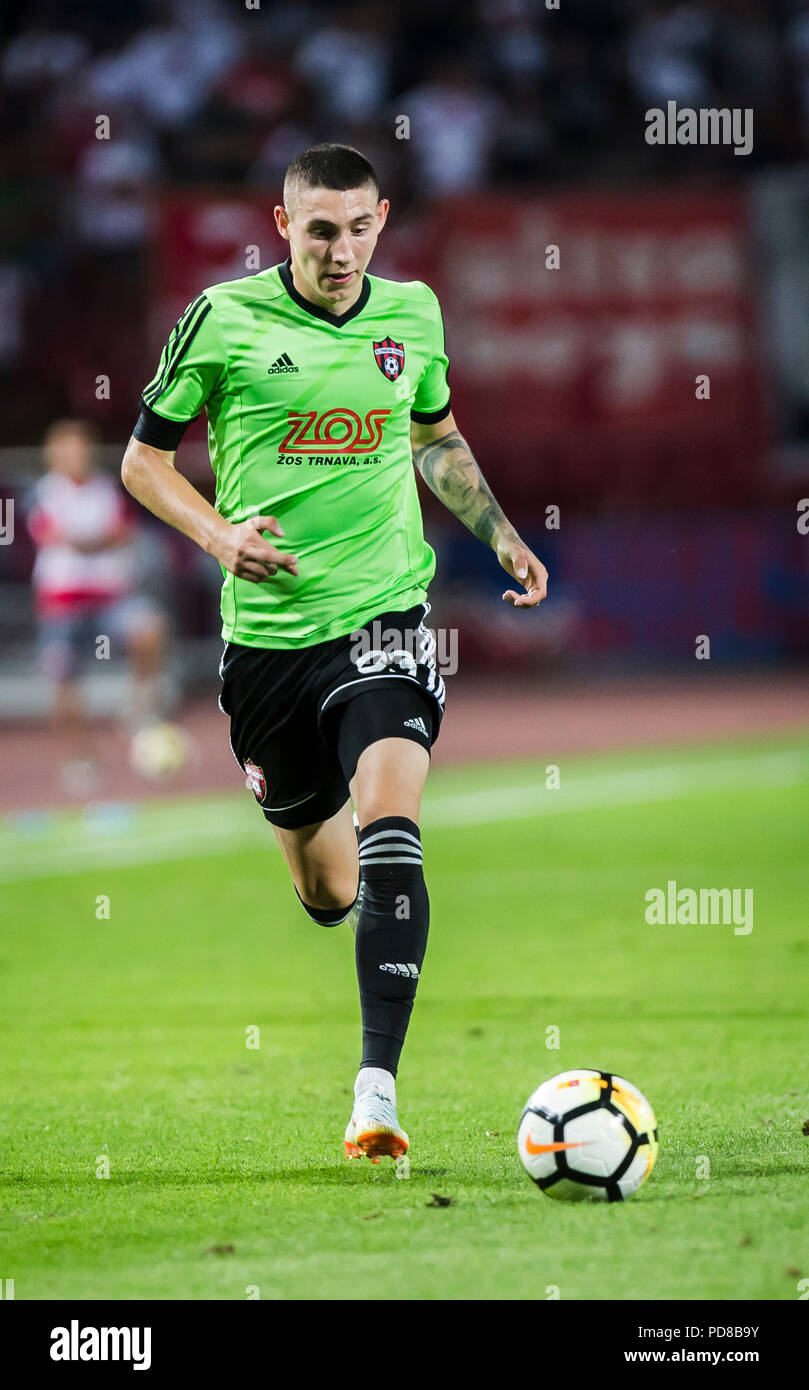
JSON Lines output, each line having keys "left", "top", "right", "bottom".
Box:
{"left": 410, "top": 411, "right": 548, "bottom": 607}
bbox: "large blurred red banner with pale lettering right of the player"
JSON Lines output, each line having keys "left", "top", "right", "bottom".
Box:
{"left": 434, "top": 190, "right": 763, "bottom": 507}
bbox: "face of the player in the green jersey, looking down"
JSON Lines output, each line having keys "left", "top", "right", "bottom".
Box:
{"left": 275, "top": 183, "right": 389, "bottom": 314}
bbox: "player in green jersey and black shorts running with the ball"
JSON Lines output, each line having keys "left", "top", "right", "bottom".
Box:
{"left": 122, "top": 145, "right": 548, "bottom": 1161}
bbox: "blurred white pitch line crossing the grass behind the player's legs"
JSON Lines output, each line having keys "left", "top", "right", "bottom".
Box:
{"left": 0, "top": 752, "right": 809, "bottom": 883}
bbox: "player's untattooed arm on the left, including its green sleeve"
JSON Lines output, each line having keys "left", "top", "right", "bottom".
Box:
{"left": 121, "top": 295, "right": 297, "bottom": 584}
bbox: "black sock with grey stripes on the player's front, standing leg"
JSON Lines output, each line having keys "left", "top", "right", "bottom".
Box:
{"left": 356, "top": 816, "right": 430, "bottom": 1076}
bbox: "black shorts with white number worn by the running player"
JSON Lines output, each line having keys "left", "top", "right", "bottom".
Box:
{"left": 220, "top": 603, "right": 445, "bottom": 830}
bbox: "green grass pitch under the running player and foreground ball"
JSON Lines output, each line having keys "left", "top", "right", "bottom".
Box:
{"left": 0, "top": 737, "right": 809, "bottom": 1300}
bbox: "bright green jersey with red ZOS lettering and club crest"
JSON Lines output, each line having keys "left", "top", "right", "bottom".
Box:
{"left": 136, "top": 261, "right": 449, "bottom": 648}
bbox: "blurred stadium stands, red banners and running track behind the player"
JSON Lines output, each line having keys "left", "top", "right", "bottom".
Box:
{"left": 0, "top": 0, "right": 809, "bottom": 819}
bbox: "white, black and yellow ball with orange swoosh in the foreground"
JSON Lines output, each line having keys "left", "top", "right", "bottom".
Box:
{"left": 517, "top": 1069, "right": 657, "bottom": 1202}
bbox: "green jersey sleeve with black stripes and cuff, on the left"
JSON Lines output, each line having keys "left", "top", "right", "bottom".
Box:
{"left": 133, "top": 295, "right": 227, "bottom": 449}
